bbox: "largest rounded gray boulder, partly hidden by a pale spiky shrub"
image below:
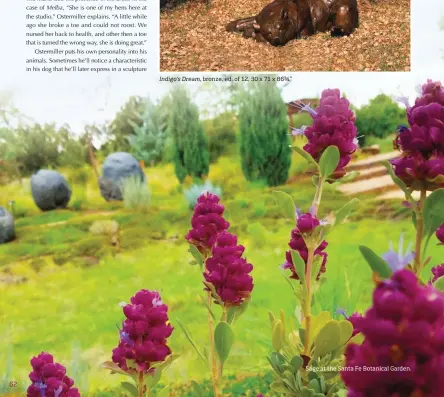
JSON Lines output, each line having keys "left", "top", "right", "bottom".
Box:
{"left": 99, "top": 152, "right": 145, "bottom": 201}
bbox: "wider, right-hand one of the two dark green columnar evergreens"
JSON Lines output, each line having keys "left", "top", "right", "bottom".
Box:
{"left": 239, "top": 82, "right": 291, "bottom": 186}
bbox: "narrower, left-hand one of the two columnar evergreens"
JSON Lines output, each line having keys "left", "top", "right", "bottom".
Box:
{"left": 167, "top": 86, "right": 209, "bottom": 183}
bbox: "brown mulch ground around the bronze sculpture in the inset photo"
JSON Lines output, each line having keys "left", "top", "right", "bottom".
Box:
{"left": 160, "top": 0, "right": 410, "bottom": 72}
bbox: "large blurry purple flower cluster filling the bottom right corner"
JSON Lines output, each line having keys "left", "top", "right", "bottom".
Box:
{"left": 341, "top": 269, "right": 444, "bottom": 397}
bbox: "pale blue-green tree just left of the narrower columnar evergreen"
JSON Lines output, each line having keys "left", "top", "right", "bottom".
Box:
{"left": 127, "top": 99, "right": 166, "bottom": 165}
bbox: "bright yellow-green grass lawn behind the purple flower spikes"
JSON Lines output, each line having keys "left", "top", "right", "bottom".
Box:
{"left": 0, "top": 153, "right": 437, "bottom": 396}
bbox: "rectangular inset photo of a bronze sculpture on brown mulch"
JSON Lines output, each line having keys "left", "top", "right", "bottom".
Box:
{"left": 160, "top": 0, "right": 410, "bottom": 72}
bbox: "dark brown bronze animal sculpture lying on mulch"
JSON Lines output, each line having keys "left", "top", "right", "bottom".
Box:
{"left": 226, "top": 0, "right": 359, "bottom": 46}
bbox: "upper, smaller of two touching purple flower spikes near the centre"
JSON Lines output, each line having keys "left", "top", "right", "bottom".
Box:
{"left": 186, "top": 192, "right": 230, "bottom": 256}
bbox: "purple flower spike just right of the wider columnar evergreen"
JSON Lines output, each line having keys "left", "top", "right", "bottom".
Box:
{"left": 294, "top": 89, "right": 358, "bottom": 177}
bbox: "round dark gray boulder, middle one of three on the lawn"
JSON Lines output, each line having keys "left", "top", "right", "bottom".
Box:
{"left": 31, "top": 170, "right": 72, "bottom": 211}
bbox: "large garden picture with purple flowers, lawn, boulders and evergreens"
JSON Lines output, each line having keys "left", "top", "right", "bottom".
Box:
{"left": 0, "top": 75, "right": 444, "bottom": 397}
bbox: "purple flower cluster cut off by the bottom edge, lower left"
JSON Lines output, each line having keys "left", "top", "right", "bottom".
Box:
{"left": 26, "top": 352, "right": 80, "bottom": 397}
